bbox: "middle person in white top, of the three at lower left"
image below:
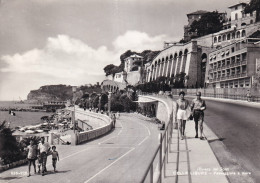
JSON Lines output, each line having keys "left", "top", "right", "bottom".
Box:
{"left": 38, "top": 137, "right": 51, "bottom": 176}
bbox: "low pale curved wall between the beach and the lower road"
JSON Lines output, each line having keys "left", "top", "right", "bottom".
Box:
{"left": 71, "top": 111, "right": 113, "bottom": 145}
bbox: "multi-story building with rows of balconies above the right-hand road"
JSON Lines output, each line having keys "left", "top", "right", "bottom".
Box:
{"left": 206, "top": 38, "right": 260, "bottom": 88}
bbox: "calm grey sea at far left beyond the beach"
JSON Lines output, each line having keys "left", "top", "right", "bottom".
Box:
{"left": 0, "top": 101, "right": 53, "bottom": 128}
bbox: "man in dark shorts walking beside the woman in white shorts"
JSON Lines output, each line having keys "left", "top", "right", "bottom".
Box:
{"left": 191, "top": 92, "right": 206, "bottom": 140}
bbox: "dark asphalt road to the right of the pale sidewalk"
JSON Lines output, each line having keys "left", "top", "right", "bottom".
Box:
{"left": 176, "top": 98, "right": 260, "bottom": 182}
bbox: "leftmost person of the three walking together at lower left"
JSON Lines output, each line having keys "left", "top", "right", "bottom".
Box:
{"left": 27, "top": 140, "right": 37, "bottom": 177}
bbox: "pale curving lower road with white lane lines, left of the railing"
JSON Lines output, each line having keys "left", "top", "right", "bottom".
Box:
{"left": 0, "top": 114, "right": 159, "bottom": 183}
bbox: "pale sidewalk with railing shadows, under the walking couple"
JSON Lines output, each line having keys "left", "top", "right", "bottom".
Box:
{"left": 163, "top": 121, "right": 228, "bottom": 183}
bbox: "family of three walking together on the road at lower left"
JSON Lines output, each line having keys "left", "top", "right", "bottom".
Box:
{"left": 26, "top": 137, "right": 59, "bottom": 177}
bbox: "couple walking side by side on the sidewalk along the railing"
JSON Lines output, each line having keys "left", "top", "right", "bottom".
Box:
{"left": 175, "top": 91, "right": 206, "bottom": 140}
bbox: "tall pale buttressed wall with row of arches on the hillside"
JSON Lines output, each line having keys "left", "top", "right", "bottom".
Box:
{"left": 145, "top": 40, "right": 208, "bottom": 87}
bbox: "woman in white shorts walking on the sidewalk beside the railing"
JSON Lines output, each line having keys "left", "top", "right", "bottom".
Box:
{"left": 175, "top": 91, "right": 189, "bottom": 140}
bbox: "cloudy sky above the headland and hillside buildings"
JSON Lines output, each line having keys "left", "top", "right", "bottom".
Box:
{"left": 0, "top": 0, "right": 239, "bottom": 100}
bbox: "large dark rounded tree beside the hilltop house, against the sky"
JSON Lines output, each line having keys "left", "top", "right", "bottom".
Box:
{"left": 189, "top": 11, "right": 223, "bottom": 37}
